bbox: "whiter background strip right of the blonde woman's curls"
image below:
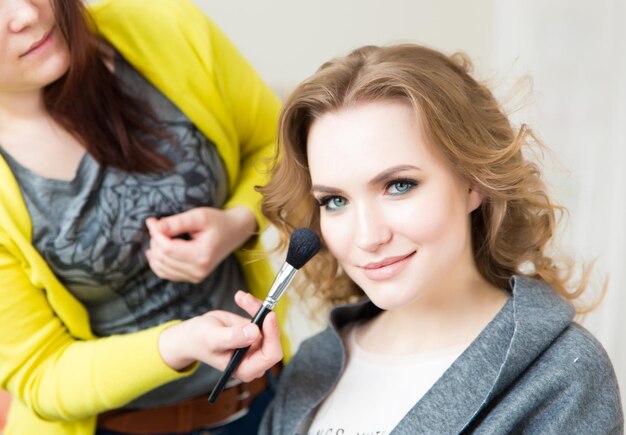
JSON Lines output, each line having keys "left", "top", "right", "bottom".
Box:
{"left": 492, "top": 0, "right": 626, "bottom": 412}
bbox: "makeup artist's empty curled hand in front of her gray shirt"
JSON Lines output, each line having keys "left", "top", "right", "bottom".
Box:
{"left": 146, "top": 206, "right": 256, "bottom": 284}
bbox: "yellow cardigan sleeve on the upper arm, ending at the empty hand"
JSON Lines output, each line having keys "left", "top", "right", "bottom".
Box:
{"left": 89, "top": 0, "right": 280, "bottom": 229}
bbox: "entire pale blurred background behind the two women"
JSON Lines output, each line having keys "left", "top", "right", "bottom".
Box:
{"left": 195, "top": 0, "right": 626, "bottom": 412}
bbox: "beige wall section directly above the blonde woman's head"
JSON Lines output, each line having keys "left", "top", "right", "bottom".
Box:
{"left": 196, "top": 0, "right": 493, "bottom": 95}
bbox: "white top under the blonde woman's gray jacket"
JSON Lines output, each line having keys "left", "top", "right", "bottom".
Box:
{"left": 308, "top": 327, "right": 466, "bottom": 435}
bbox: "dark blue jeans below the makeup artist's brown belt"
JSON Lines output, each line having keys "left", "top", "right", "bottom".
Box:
{"left": 96, "top": 379, "right": 276, "bottom": 435}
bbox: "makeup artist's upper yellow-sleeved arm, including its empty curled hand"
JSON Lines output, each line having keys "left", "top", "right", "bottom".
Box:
{"left": 92, "top": 0, "right": 280, "bottom": 282}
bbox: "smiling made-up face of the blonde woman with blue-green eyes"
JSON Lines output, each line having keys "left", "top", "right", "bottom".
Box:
{"left": 307, "top": 101, "right": 480, "bottom": 309}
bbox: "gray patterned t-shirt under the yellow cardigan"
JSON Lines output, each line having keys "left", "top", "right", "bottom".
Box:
{"left": 0, "top": 52, "right": 246, "bottom": 407}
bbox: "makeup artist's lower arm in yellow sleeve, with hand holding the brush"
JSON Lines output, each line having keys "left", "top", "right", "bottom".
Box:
{"left": 0, "top": 243, "right": 282, "bottom": 420}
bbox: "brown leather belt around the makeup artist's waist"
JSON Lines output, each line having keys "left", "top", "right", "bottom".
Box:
{"left": 98, "top": 364, "right": 281, "bottom": 435}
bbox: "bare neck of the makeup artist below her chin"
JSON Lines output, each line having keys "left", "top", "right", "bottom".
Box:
{"left": 0, "top": 89, "right": 47, "bottom": 131}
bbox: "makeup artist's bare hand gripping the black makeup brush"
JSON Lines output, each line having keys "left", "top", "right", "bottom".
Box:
{"left": 159, "top": 291, "right": 283, "bottom": 382}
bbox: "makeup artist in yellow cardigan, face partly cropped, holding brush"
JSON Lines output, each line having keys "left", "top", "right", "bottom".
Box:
{"left": 0, "top": 0, "right": 286, "bottom": 434}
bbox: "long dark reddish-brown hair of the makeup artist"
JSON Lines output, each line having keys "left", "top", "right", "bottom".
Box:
{"left": 43, "top": 0, "right": 171, "bottom": 172}
